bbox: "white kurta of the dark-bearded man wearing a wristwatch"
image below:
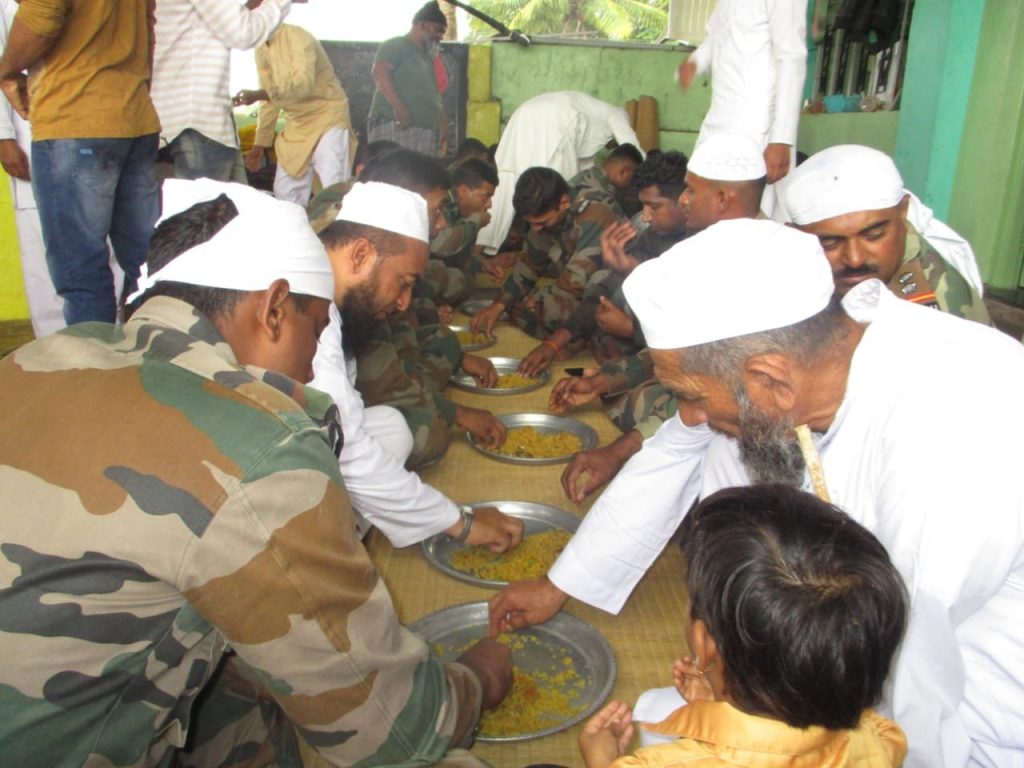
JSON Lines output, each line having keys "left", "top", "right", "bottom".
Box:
{"left": 311, "top": 305, "right": 459, "bottom": 547}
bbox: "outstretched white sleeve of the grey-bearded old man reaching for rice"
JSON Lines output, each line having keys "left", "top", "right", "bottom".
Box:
{"left": 548, "top": 418, "right": 713, "bottom": 613}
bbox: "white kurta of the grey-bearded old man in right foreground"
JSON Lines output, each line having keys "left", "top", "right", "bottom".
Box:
{"left": 550, "top": 281, "right": 1024, "bottom": 768}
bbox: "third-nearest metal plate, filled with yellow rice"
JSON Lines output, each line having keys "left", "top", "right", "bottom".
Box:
{"left": 466, "top": 414, "right": 597, "bottom": 465}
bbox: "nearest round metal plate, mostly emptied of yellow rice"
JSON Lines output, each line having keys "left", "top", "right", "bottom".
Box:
{"left": 410, "top": 602, "right": 617, "bottom": 742}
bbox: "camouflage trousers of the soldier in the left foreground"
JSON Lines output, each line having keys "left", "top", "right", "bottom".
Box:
{"left": 169, "top": 653, "right": 490, "bottom": 768}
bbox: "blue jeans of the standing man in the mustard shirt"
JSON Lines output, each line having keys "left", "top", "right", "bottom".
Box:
{"left": 32, "top": 133, "right": 160, "bottom": 325}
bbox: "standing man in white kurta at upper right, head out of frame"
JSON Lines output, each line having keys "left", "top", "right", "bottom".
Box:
{"left": 679, "top": 0, "right": 807, "bottom": 214}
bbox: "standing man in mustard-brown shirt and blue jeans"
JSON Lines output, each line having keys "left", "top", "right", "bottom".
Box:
{"left": 0, "top": 0, "right": 160, "bottom": 325}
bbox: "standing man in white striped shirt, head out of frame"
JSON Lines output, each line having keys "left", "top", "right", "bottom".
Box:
{"left": 151, "top": 0, "right": 292, "bottom": 183}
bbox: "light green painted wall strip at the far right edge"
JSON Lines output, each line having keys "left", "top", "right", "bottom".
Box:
{"left": 948, "top": 0, "right": 1024, "bottom": 289}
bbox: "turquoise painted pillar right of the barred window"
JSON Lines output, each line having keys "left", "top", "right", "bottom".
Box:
{"left": 895, "top": 0, "right": 985, "bottom": 220}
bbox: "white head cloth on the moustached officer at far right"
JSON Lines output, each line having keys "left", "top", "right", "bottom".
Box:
{"left": 784, "top": 144, "right": 906, "bottom": 224}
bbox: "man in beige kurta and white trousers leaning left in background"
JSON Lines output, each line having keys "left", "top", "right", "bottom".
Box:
{"left": 234, "top": 24, "right": 355, "bottom": 207}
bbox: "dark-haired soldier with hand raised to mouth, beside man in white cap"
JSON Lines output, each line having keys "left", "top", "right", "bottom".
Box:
{"left": 519, "top": 152, "right": 686, "bottom": 376}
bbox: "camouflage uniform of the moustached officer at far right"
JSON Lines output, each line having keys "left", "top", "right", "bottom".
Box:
{"left": 889, "top": 227, "right": 992, "bottom": 326}
